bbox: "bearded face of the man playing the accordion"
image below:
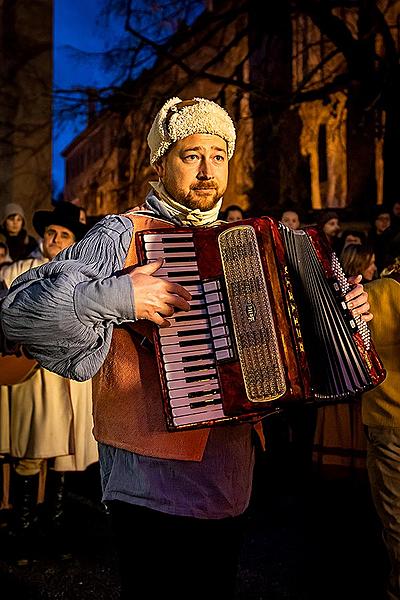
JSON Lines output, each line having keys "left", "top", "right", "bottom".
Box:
{"left": 155, "top": 133, "right": 228, "bottom": 211}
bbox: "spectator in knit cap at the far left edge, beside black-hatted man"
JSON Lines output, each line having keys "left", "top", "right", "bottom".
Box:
{"left": 0, "top": 203, "right": 37, "bottom": 260}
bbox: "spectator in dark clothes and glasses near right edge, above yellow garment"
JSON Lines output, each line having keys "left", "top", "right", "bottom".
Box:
{"left": 368, "top": 205, "right": 395, "bottom": 273}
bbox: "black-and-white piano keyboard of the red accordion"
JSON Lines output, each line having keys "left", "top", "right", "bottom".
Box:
{"left": 143, "top": 231, "right": 233, "bottom": 427}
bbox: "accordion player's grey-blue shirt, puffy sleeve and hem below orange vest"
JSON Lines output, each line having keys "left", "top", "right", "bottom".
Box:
{"left": 2, "top": 194, "right": 254, "bottom": 519}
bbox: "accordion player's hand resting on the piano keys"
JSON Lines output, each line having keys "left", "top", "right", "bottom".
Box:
{"left": 129, "top": 258, "right": 192, "bottom": 327}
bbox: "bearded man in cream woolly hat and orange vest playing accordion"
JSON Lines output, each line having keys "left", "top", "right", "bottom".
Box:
{"left": 2, "top": 97, "right": 370, "bottom": 600}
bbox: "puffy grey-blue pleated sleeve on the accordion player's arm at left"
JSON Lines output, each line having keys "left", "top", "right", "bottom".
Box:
{"left": 1, "top": 215, "right": 135, "bottom": 381}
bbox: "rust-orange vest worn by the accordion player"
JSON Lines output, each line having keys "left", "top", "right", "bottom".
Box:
{"left": 93, "top": 210, "right": 263, "bottom": 461}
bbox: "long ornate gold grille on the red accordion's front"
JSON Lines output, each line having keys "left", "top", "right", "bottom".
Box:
{"left": 218, "top": 225, "right": 286, "bottom": 402}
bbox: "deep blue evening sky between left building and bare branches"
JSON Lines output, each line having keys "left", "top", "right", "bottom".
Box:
{"left": 53, "top": 0, "right": 203, "bottom": 196}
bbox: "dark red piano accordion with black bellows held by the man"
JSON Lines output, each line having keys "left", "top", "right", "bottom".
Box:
{"left": 136, "top": 217, "right": 385, "bottom": 431}
